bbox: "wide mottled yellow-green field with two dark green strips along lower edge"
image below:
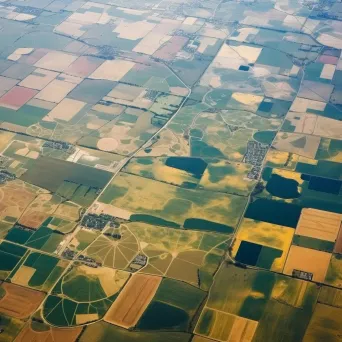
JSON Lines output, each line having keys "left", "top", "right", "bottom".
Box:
{"left": 99, "top": 173, "right": 246, "bottom": 233}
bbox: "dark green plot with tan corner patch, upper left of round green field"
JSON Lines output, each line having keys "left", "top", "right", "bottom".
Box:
{"left": 11, "top": 252, "right": 68, "bottom": 292}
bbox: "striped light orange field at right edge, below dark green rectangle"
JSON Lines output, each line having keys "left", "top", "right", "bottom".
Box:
{"left": 296, "top": 208, "right": 342, "bottom": 242}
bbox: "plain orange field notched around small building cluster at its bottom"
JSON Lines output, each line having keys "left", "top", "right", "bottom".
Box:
{"left": 283, "top": 245, "right": 331, "bottom": 282}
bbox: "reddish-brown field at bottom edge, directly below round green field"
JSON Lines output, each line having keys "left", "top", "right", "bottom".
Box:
{"left": 14, "top": 322, "right": 82, "bottom": 342}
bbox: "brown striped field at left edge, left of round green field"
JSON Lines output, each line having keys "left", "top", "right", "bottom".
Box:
{"left": 0, "top": 283, "right": 45, "bottom": 319}
